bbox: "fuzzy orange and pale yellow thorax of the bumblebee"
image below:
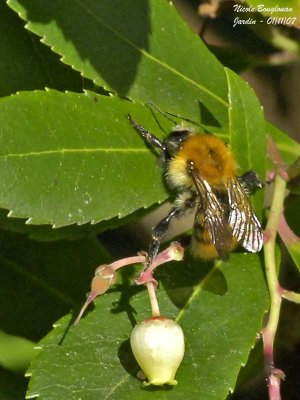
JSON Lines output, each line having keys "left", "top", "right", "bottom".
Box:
{"left": 168, "top": 135, "right": 236, "bottom": 188}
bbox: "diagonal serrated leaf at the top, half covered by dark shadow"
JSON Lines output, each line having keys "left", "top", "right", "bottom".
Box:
{"left": 8, "top": 0, "right": 228, "bottom": 127}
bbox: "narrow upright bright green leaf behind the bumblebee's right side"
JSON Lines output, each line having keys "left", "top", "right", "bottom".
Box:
{"left": 225, "top": 68, "right": 266, "bottom": 214}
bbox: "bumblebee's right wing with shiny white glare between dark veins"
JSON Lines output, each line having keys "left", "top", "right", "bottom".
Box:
{"left": 227, "top": 178, "right": 263, "bottom": 253}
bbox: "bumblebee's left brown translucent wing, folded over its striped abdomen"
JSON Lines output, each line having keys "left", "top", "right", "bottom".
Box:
{"left": 191, "top": 170, "right": 232, "bottom": 258}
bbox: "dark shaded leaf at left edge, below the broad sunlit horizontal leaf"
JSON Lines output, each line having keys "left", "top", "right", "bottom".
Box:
{"left": 0, "top": 230, "right": 108, "bottom": 340}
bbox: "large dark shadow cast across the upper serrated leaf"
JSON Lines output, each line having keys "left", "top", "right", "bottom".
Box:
{"left": 14, "top": 0, "right": 151, "bottom": 96}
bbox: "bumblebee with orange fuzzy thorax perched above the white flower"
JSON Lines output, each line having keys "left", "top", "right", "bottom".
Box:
{"left": 128, "top": 115, "right": 263, "bottom": 268}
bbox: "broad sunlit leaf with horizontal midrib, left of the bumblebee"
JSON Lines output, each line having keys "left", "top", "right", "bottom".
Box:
{"left": 0, "top": 91, "right": 166, "bottom": 226}
